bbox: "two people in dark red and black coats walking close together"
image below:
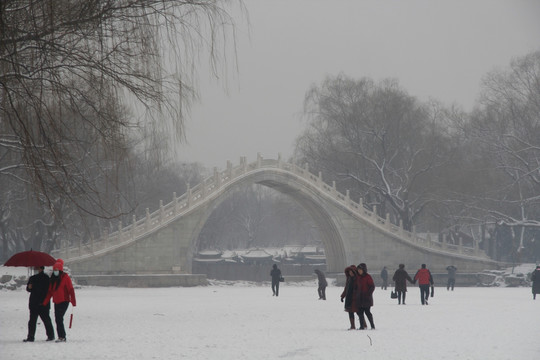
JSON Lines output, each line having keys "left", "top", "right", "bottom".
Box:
{"left": 341, "top": 263, "right": 375, "bottom": 330}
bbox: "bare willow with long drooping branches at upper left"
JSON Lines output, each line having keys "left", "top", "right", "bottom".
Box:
{"left": 0, "top": 0, "right": 234, "bottom": 217}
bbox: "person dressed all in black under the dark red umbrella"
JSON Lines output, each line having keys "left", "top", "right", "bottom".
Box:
{"left": 23, "top": 266, "right": 54, "bottom": 342}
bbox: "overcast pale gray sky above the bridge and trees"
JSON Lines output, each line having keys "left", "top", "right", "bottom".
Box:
{"left": 180, "top": 0, "right": 540, "bottom": 168}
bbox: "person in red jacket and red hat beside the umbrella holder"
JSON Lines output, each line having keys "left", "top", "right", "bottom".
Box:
{"left": 43, "top": 259, "right": 77, "bottom": 342}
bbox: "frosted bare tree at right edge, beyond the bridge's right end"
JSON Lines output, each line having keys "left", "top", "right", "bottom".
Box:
{"left": 454, "top": 52, "right": 540, "bottom": 258}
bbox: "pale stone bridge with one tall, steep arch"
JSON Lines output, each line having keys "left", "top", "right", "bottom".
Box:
{"left": 53, "top": 155, "right": 497, "bottom": 284}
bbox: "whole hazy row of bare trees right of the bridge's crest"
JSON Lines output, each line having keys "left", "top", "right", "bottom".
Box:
{"left": 295, "top": 51, "right": 540, "bottom": 262}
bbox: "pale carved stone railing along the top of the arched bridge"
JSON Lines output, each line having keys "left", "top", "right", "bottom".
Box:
{"left": 53, "top": 154, "right": 487, "bottom": 259}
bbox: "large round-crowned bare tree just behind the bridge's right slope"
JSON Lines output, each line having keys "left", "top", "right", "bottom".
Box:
{"left": 297, "top": 75, "right": 452, "bottom": 229}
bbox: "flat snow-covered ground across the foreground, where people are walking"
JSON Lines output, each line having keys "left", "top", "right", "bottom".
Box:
{"left": 0, "top": 270, "right": 540, "bottom": 360}
